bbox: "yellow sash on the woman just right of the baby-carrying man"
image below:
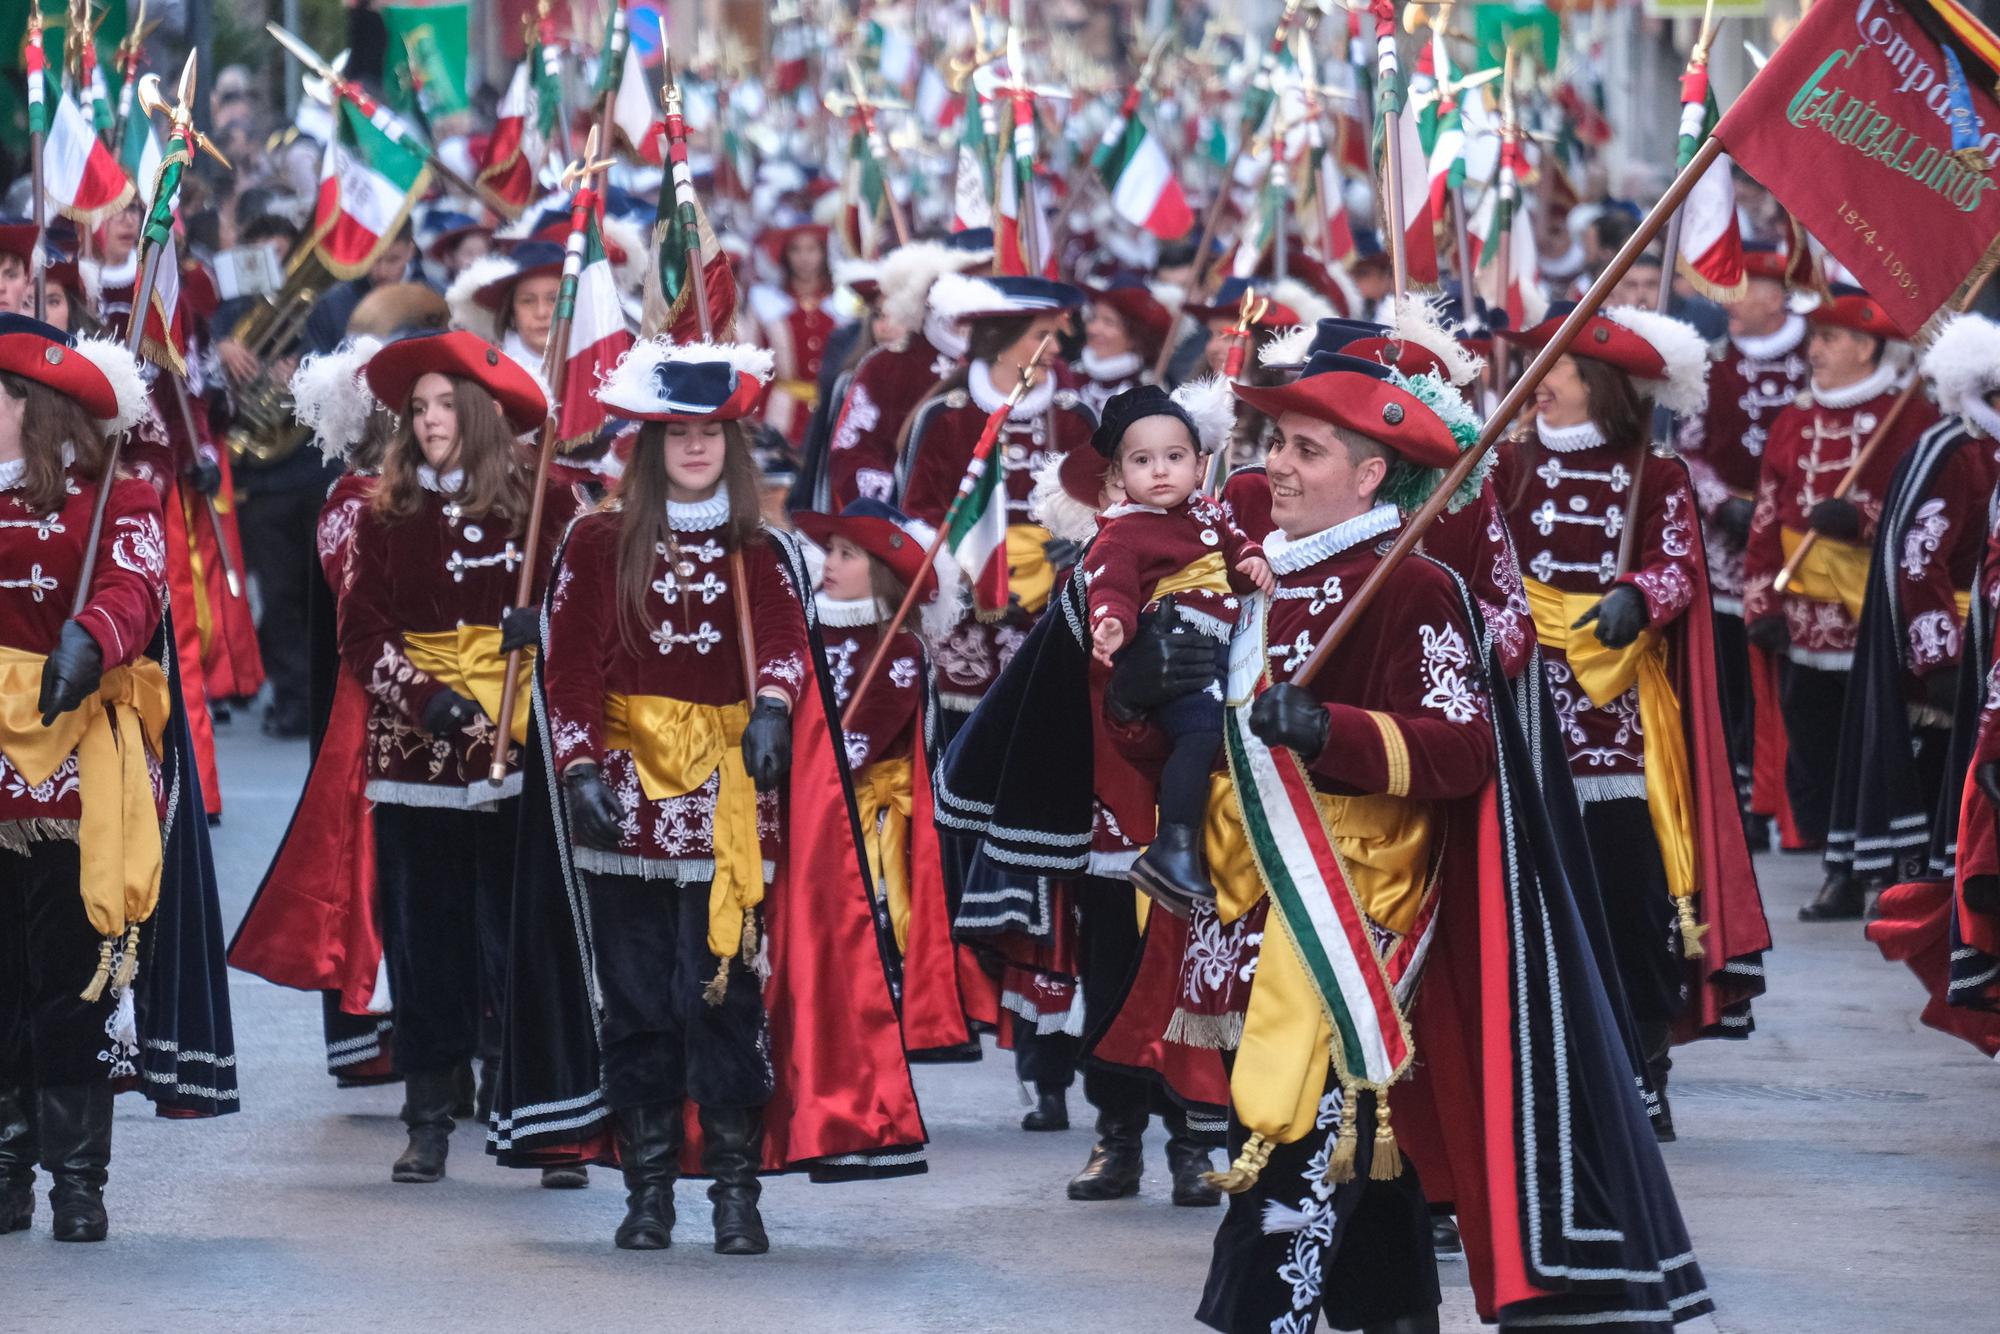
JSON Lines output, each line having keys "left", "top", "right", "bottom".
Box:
{"left": 1522, "top": 580, "right": 1696, "bottom": 898}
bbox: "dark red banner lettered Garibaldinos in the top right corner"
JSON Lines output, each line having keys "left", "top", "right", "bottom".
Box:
{"left": 1716, "top": 0, "right": 2000, "bottom": 334}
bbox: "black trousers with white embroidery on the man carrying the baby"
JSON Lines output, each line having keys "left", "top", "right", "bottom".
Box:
{"left": 1194, "top": 1076, "right": 1440, "bottom": 1334}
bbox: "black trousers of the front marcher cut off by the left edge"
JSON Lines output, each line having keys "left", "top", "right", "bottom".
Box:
{"left": 0, "top": 840, "right": 114, "bottom": 1088}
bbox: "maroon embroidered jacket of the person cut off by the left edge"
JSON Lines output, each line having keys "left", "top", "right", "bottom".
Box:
{"left": 0, "top": 464, "right": 166, "bottom": 828}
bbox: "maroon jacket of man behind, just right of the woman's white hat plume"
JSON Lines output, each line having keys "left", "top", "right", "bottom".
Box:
{"left": 1678, "top": 316, "right": 1808, "bottom": 616}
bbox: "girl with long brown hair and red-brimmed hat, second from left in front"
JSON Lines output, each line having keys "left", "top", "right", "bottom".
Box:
{"left": 340, "top": 332, "right": 580, "bottom": 1184}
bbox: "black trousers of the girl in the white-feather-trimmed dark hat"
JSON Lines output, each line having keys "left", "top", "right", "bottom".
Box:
{"left": 584, "top": 872, "right": 772, "bottom": 1110}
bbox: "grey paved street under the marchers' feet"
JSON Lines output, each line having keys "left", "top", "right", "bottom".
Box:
{"left": 11, "top": 716, "right": 2000, "bottom": 1334}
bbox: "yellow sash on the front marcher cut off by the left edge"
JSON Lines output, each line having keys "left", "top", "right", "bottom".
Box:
{"left": 0, "top": 646, "right": 170, "bottom": 936}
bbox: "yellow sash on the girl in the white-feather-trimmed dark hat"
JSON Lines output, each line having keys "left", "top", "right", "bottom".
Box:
{"left": 604, "top": 694, "right": 764, "bottom": 958}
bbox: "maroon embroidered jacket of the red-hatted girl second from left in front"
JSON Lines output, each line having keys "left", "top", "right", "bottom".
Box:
{"left": 340, "top": 468, "right": 578, "bottom": 808}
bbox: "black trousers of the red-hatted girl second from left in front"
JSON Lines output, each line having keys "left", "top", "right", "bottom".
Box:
{"left": 374, "top": 798, "right": 520, "bottom": 1074}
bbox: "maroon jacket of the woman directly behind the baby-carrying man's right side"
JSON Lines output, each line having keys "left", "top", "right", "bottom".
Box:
{"left": 1494, "top": 434, "right": 1706, "bottom": 802}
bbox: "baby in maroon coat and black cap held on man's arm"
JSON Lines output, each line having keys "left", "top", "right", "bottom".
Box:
{"left": 1084, "top": 384, "right": 1272, "bottom": 914}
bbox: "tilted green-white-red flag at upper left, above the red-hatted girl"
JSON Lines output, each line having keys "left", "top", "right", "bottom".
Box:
{"left": 308, "top": 90, "right": 430, "bottom": 278}
